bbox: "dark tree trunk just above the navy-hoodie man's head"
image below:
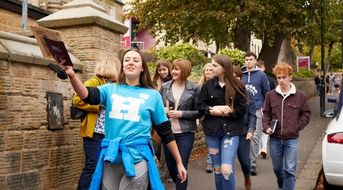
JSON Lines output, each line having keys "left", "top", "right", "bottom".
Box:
{"left": 234, "top": 26, "right": 250, "bottom": 52}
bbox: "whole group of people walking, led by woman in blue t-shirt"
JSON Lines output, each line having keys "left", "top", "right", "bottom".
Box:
{"left": 60, "top": 49, "right": 310, "bottom": 190}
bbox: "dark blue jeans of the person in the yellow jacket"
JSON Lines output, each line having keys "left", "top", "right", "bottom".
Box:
{"left": 77, "top": 133, "right": 104, "bottom": 190}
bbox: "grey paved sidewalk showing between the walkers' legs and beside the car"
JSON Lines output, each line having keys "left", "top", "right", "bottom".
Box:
{"left": 166, "top": 96, "right": 334, "bottom": 190}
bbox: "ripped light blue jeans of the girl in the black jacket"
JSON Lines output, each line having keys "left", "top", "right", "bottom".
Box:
{"left": 205, "top": 135, "right": 239, "bottom": 190}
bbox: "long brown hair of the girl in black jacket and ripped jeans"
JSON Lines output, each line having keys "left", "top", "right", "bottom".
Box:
{"left": 213, "top": 55, "right": 247, "bottom": 107}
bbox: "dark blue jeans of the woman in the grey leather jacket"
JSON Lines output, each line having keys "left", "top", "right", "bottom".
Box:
{"left": 163, "top": 132, "right": 194, "bottom": 190}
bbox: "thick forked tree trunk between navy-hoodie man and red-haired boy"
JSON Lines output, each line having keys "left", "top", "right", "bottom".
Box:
{"left": 258, "top": 34, "right": 286, "bottom": 73}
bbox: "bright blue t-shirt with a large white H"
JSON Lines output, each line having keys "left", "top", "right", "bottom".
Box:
{"left": 98, "top": 84, "right": 168, "bottom": 163}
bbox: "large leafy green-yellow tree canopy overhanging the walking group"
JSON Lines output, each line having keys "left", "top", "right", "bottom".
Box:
{"left": 128, "top": 0, "right": 342, "bottom": 72}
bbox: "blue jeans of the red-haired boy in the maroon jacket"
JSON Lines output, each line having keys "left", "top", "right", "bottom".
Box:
{"left": 269, "top": 137, "right": 299, "bottom": 190}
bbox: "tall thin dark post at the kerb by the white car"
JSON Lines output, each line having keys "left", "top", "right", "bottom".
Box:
{"left": 320, "top": 0, "right": 326, "bottom": 117}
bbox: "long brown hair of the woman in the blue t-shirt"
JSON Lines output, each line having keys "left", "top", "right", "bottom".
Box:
{"left": 118, "top": 48, "right": 154, "bottom": 88}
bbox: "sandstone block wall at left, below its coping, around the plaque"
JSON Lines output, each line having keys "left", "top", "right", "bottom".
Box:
{"left": 0, "top": 56, "right": 82, "bottom": 190}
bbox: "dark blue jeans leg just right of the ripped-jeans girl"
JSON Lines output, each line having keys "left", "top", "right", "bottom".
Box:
{"left": 237, "top": 134, "right": 250, "bottom": 176}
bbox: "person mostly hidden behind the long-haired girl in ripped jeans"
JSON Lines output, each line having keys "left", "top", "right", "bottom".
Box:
{"left": 233, "top": 66, "right": 256, "bottom": 190}
